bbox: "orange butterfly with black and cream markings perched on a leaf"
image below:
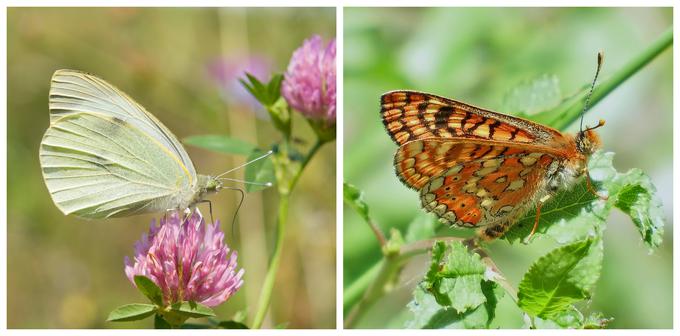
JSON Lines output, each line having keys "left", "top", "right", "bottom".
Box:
{"left": 380, "top": 55, "right": 604, "bottom": 240}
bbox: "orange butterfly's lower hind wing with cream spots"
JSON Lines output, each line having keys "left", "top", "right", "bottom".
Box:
{"left": 395, "top": 139, "right": 558, "bottom": 235}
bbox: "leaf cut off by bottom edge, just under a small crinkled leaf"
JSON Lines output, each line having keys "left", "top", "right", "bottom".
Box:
{"left": 405, "top": 281, "right": 503, "bottom": 329}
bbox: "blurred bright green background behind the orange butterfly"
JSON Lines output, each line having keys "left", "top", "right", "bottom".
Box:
{"left": 343, "top": 8, "right": 673, "bottom": 328}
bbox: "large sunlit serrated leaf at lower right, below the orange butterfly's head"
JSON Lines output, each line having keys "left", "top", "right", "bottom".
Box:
{"left": 517, "top": 239, "right": 603, "bottom": 321}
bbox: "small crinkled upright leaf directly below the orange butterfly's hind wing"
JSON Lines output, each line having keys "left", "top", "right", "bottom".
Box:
{"left": 423, "top": 241, "right": 486, "bottom": 313}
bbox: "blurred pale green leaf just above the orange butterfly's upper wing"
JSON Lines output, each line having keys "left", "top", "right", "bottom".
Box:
{"left": 501, "top": 75, "right": 562, "bottom": 116}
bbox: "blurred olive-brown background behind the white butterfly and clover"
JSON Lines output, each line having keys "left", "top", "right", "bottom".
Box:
{"left": 7, "top": 8, "right": 336, "bottom": 328}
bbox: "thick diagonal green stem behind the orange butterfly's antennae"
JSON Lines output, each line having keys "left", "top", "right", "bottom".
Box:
{"left": 548, "top": 28, "right": 673, "bottom": 129}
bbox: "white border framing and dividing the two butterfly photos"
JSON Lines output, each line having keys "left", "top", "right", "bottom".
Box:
{"left": 0, "top": 0, "right": 680, "bottom": 336}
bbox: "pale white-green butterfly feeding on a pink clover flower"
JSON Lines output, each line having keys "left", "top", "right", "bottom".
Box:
{"left": 40, "top": 70, "right": 269, "bottom": 218}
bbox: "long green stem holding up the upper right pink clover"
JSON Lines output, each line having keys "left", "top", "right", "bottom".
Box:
{"left": 251, "top": 139, "right": 324, "bottom": 329}
